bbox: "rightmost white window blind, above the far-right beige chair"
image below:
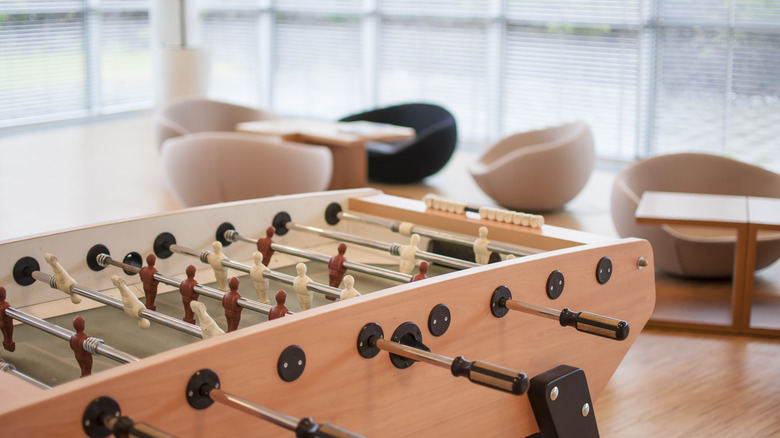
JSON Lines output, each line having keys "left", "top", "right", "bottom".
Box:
{"left": 652, "top": 0, "right": 780, "bottom": 171}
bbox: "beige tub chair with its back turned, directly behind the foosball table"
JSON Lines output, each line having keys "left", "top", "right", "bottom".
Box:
{"left": 161, "top": 132, "right": 333, "bottom": 207}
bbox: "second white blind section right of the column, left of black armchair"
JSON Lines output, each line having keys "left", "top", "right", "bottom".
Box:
{"left": 272, "top": 13, "right": 363, "bottom": 120}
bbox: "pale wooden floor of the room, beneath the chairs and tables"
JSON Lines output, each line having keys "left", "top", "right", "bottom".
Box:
{"left": 0, "top": 114, "right": 780, "bottom": 437}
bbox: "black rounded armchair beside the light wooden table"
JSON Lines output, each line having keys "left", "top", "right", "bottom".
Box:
{"left": 340, "top": 103, "right": 458, "bottom": 184}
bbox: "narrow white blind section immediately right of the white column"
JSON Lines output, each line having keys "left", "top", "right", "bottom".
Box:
{"left": 201, "top": 6, "right": 267, "bottom": 107}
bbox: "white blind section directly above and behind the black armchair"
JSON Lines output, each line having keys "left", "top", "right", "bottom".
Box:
{"left": 377, "top": 17, "right": 490, "bottom": 141}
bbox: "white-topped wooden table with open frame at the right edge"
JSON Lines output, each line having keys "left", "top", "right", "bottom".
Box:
{"left": 635, "top": 191, "right": 780, "bottom": 336}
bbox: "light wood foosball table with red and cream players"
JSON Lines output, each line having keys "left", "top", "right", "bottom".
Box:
{"left": 0, "top": 189, "right": 655, "bottom": 437}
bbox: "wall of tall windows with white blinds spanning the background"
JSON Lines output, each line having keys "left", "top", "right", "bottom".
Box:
{"left": 0, "top": 0, "right": 780, "bottom": 171}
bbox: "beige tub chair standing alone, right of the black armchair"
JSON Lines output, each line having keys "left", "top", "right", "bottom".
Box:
{"left": 469, "top": 121, "right": 595, "bottom": 211}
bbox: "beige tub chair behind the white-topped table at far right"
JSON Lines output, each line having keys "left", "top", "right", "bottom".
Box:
{"left": 611, "top": 153, "right": 780, "bottom": 278}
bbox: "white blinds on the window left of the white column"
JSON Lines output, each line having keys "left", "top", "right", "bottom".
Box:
{"left": 0, "top": 0, "right": 151, "bottom": 127}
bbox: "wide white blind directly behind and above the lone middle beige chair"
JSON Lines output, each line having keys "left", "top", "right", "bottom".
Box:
{"left": 502, "top": 2, "right": 642, "bottom": 159}
